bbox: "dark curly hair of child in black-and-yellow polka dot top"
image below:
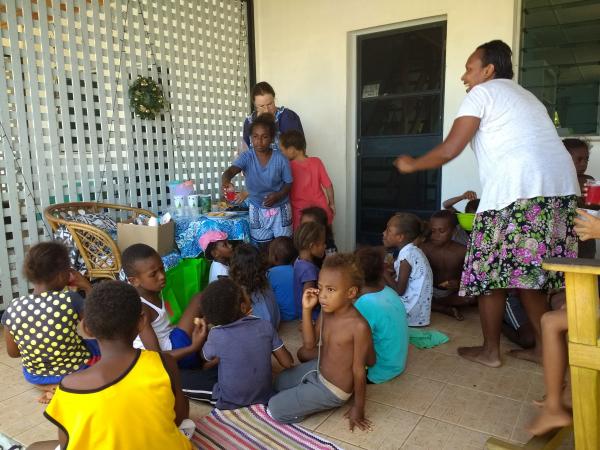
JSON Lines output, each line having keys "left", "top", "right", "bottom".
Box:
{"left": 23, "top": 241, "right": 71, "bottom": 283}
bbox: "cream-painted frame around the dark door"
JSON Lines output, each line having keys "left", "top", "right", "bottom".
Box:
{"left": 341, "top": 14, "right": 448, "bottom": 249}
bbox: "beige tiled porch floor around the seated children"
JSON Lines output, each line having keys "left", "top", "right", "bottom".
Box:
{"left": 0, "top": 309, "right": 573, "bottom": 450}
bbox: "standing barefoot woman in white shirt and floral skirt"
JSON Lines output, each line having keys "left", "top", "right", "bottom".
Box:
{"left": 394, "top": 40, "right": 579, "bottom": 367}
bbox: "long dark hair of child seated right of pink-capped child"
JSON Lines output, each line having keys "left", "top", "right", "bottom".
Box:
{"left": 229, "top": 244, "right": 269, "bottom": 295}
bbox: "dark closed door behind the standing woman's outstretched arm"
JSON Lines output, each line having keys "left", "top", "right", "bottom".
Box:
{"left": 356, "top": 22, "right": 446, "bottom": 244}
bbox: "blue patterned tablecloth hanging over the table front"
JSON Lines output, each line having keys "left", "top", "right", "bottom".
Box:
{"left": 173, "top": 213, "right": 250, "bottom": 258}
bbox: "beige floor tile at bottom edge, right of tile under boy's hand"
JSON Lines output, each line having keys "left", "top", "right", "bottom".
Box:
{"left": 402, "top": 417, "right": 489, "bottom": 450}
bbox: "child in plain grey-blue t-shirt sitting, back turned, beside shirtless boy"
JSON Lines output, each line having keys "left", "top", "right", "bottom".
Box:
{"left": 202, "top": 278, "right": 293, "bottom": 409}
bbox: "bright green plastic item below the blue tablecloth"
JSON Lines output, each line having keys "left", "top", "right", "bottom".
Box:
{"left": 162, "top": 258, "right": 210, "bottom": 324}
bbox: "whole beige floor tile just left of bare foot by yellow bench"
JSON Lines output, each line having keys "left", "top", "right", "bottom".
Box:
{"left": 425, "top": 384, "right": 521, "bottom": 439}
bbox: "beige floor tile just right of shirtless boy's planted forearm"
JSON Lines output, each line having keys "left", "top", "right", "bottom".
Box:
{"left": 367, "top": 374, "right": 444, "bottom": 415}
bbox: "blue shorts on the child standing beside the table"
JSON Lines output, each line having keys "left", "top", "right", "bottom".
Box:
{"left": 248, "top": 202, "right": 292, "bottom": 244}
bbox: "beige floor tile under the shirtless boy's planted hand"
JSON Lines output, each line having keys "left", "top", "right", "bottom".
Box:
{"left": 316, "top": 400, "right": 420, "bottom": 449}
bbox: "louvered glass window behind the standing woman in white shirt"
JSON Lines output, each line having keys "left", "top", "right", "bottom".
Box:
{"left": 520, "top": 0, "right": 600, "bottom": 135}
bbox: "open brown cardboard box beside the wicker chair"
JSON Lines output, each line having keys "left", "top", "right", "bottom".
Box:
{"left": 117, "top": 221, "right": 175, "bottom": 256}
